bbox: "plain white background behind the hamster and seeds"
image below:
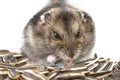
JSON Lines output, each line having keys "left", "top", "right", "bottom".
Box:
{"left": 0, "top": 0, "right": 120, "bottom": 61}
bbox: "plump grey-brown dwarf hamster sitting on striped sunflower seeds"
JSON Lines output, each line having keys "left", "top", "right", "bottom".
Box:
{"left": 22, "top": 0, "right": 95, "bottom": 64}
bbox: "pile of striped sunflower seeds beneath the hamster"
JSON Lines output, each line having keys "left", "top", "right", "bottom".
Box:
{"left": 0, "top": 50, "right": 120, "bottom": 80}
